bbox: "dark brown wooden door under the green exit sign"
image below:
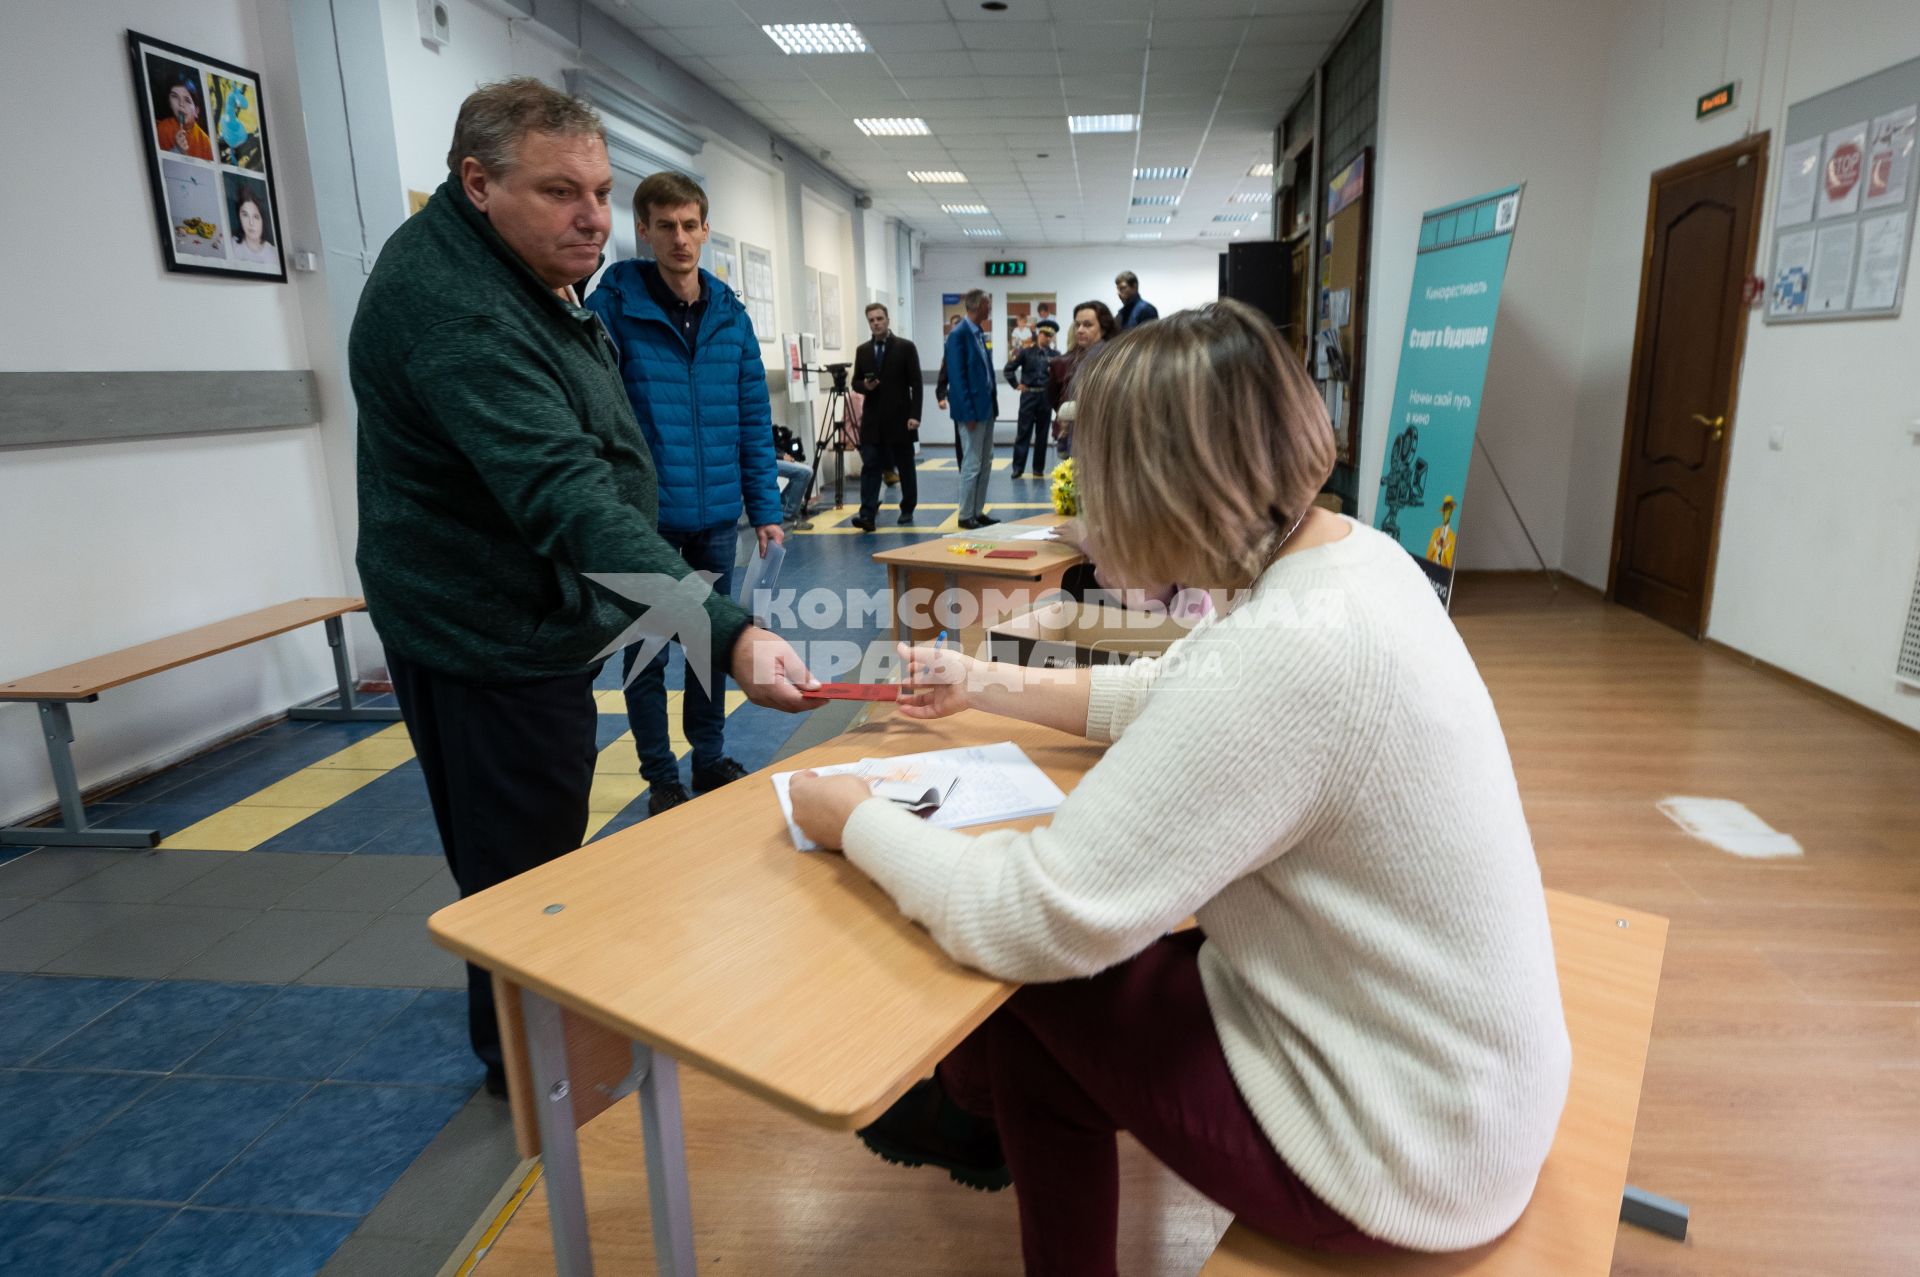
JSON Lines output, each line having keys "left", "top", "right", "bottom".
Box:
{"left": 1607, "top": 133, "right": 1766, "bottom": 638}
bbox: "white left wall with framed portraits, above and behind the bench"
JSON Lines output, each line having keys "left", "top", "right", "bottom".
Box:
{"left": 0, "top": 0, "right": 351, "bottom": 820}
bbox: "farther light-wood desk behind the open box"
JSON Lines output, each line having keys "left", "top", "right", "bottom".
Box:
{"left": 874, "top": 515, "right": 1087, "bottom": 655}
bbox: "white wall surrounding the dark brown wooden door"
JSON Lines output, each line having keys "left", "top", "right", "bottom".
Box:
{"left": 1559, "top": 0, "right": 1920, "bottom": 726}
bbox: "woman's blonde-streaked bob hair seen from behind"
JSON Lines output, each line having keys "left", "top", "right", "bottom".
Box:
{"left": 1073, "top": 301, "right": 1334, "bottom": 590}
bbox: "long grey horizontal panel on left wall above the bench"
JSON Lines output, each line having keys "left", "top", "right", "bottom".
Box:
{"left": 0, "top": 371, "right": 321, "bottom": 447}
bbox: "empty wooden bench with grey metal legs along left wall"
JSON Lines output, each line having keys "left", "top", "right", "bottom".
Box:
{"left": 0, "top": 599, "right": 399, "bottom": 847}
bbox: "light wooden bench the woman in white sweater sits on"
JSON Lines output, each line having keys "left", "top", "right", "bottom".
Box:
{"left": 1200, "top": 891, "right": 1686, "bottom": 1277}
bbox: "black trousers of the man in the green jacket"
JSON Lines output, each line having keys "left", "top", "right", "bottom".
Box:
{"left": 386, "top": 649, "right": 599, "bottom": 1070}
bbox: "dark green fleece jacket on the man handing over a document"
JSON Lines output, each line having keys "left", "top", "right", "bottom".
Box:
{"left": 348, "top": 182, "right": 747, "bottom": 682}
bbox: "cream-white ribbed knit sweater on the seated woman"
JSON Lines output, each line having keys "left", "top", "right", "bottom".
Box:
{"left": 845, "top": 524, "right": 1571, "bottom": 1250}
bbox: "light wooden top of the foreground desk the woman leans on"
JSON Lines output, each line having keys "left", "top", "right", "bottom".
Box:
{"left": 428, "top": 712, "right": 1102, "bottom": 1129}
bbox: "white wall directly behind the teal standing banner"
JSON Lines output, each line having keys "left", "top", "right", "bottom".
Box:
{"left": 1359, "top": 0, "right": 1620, "bottom": 568}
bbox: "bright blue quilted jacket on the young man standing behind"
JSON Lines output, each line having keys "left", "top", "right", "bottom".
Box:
{"left": 588, "top": 259, "right": 780, "bottom": 532}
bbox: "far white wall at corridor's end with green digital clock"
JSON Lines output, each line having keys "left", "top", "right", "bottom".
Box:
{"left": 914, "top": 242, "right": 1225, "bottom": 444}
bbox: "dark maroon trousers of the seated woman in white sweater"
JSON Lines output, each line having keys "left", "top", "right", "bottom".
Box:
{"left": 939, "top": 931, "right": 1394, "bottom": 1277}
